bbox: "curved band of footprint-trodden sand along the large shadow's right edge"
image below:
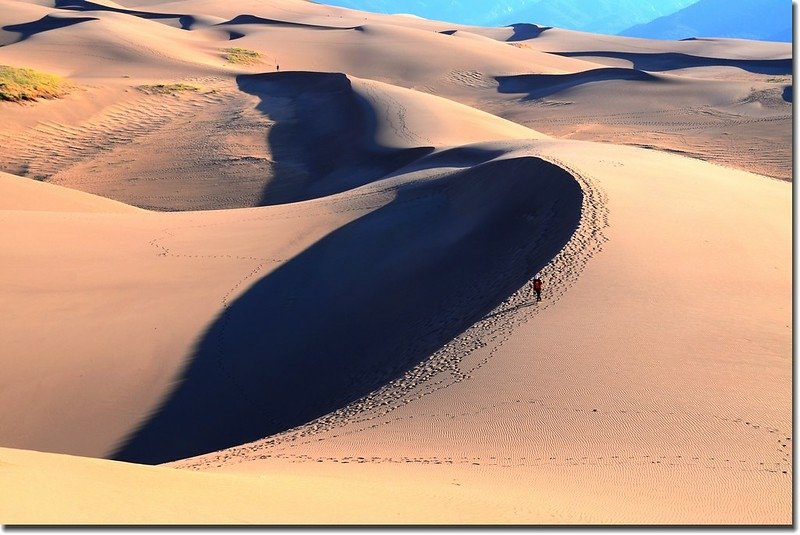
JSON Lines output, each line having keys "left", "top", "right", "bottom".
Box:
{"left": 181, "top": 157, "right": 609, "bottom": 467}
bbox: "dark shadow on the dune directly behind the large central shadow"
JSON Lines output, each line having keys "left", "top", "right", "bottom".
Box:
{"left": 237, "top": 72, "right": 434, "bottom": 205}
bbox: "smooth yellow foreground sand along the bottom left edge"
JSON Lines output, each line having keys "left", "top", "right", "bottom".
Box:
{"left": 0, "top": 448, "right": 604, "bottom": 525}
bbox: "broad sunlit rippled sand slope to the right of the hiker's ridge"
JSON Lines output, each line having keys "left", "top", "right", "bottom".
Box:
{"left": 172, "top": 142, "right": 792, "bottom": 523}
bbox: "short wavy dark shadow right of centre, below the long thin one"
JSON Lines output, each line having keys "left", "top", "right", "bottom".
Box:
{"left": 495, "top": 67, "right": 661, "bottom": 100}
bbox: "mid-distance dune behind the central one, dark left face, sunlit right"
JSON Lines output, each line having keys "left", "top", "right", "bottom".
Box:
{"left": 231, "top": 72, "right": 544, "bottom": 204}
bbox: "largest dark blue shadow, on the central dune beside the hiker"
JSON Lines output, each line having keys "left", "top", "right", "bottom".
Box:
{"left": 113, "top": 157, "right": 583, "bottom": 463}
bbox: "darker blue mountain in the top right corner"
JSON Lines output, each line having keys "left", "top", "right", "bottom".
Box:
{"left": 620, "top": 0, "right": 792, "bottom": 42}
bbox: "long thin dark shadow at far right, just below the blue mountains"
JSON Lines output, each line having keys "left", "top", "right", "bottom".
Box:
{"left": 553, "top": 51, "right": 792, "bottom": 74}
